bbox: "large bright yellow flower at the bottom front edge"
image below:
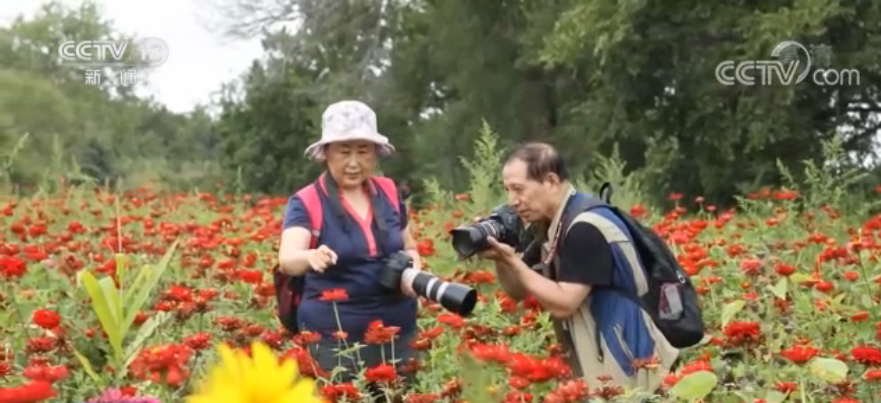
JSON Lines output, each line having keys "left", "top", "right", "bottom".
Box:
{"left": 186, "top": 343, "right": 325, "bottom": 403}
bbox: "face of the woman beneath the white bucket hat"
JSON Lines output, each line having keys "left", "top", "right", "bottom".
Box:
{"left": 324, "top": 140, "right": 376, "bottom": 188}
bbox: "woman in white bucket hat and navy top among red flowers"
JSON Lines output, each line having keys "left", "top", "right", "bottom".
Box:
{"left": 279, "top": 101, "right": 421, "bottom": 392}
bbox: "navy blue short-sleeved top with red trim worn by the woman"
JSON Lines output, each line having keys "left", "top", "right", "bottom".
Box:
{"left": 282, "top": 185, "right": 417, "bottom": 341}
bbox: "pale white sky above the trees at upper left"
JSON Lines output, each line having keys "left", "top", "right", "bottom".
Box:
{"left": 0, "top": 0, "right": 262, "bottom": 113}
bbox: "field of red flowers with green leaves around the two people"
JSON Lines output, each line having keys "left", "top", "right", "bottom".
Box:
{"left": 0, "top": 178, "right": 881, "bottom": 403}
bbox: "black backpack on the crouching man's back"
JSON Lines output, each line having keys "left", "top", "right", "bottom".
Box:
{"left": 561, "top": 182, "right": 704, "bottom": 349}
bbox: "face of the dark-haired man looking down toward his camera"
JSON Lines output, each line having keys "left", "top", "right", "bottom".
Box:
{"left": 502, "top": 160, "right": 554, "bottom": 222}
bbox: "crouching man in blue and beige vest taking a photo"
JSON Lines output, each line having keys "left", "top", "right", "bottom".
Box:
{"left": 481, "top": 143, "right": 679, "bottom": 393}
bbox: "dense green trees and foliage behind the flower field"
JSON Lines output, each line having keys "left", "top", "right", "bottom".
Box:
{"left": 0, "top": 0, "right": 881, "bottom": 206}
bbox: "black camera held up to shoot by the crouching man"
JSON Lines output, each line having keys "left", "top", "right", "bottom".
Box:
{"left": 450, "top": 204, "right": 523, "bottom": 258}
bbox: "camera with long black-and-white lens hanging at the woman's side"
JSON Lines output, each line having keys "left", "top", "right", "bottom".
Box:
{"left": 379, "top": 252, "right": 477, "bottom": 317}
